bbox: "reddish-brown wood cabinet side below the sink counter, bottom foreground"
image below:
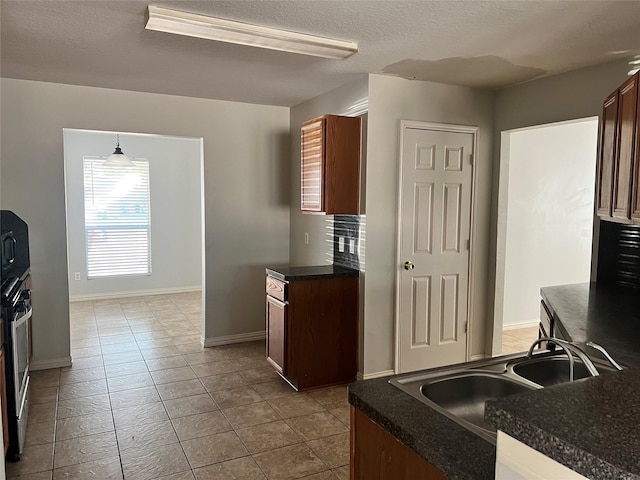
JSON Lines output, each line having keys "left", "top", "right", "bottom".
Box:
{"left": 350, "top": 406, "right": 447, "bottom": 480}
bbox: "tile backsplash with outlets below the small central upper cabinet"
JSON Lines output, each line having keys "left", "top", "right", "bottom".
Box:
{"left": 327, "top": 215, "right": 366, "bottom": 271}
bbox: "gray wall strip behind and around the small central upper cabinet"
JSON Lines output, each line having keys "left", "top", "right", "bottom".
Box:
{"left": 290, "top": 78, "right": 368, "bottom": 265}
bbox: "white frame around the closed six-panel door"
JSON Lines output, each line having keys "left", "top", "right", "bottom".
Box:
{"left": 393, "top": 120, "right": 479, "bottom": 373}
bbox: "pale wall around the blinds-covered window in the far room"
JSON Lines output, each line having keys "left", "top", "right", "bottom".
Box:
{"left": 63, "top": 130, "right": 202, "bottom": 298}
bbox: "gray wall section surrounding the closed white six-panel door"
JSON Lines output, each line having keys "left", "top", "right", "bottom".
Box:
{"left": 364, "top": 75, "right": 494, "bottom": 375}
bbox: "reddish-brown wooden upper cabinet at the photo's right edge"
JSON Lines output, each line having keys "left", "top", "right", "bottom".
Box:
{"left": 597, "top": 74, "right": 640, "bottom": 223}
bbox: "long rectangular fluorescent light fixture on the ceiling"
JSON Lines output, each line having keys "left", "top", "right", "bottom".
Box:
{"left": 145, "top": 5, "right": 358, "bottom": 59}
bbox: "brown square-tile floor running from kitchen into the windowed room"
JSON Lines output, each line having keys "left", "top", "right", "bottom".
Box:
{"left": 7, "top": 294, "right": 349, "bottom": 480}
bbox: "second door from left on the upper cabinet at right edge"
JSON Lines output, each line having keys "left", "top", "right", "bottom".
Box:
{"left": 611, "top": 75, "right": 638, "bottom": 220}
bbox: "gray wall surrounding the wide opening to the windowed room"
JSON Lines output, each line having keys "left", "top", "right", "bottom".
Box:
{"left": 0, "top": 79, "right": 290, "bottom": 365}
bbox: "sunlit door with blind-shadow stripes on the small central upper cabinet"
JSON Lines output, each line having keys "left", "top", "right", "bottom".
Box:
{"left": 300, "top": 118, "right": 325, "bottom": 212}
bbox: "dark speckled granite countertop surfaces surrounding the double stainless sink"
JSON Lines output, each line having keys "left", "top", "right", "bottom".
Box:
{"left": 349, "top": 283, "right": 640, "bottom": 480}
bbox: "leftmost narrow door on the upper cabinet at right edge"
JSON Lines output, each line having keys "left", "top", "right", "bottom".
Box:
{"left": 598, "top": 90, "right": 618, "bottom": 217}
